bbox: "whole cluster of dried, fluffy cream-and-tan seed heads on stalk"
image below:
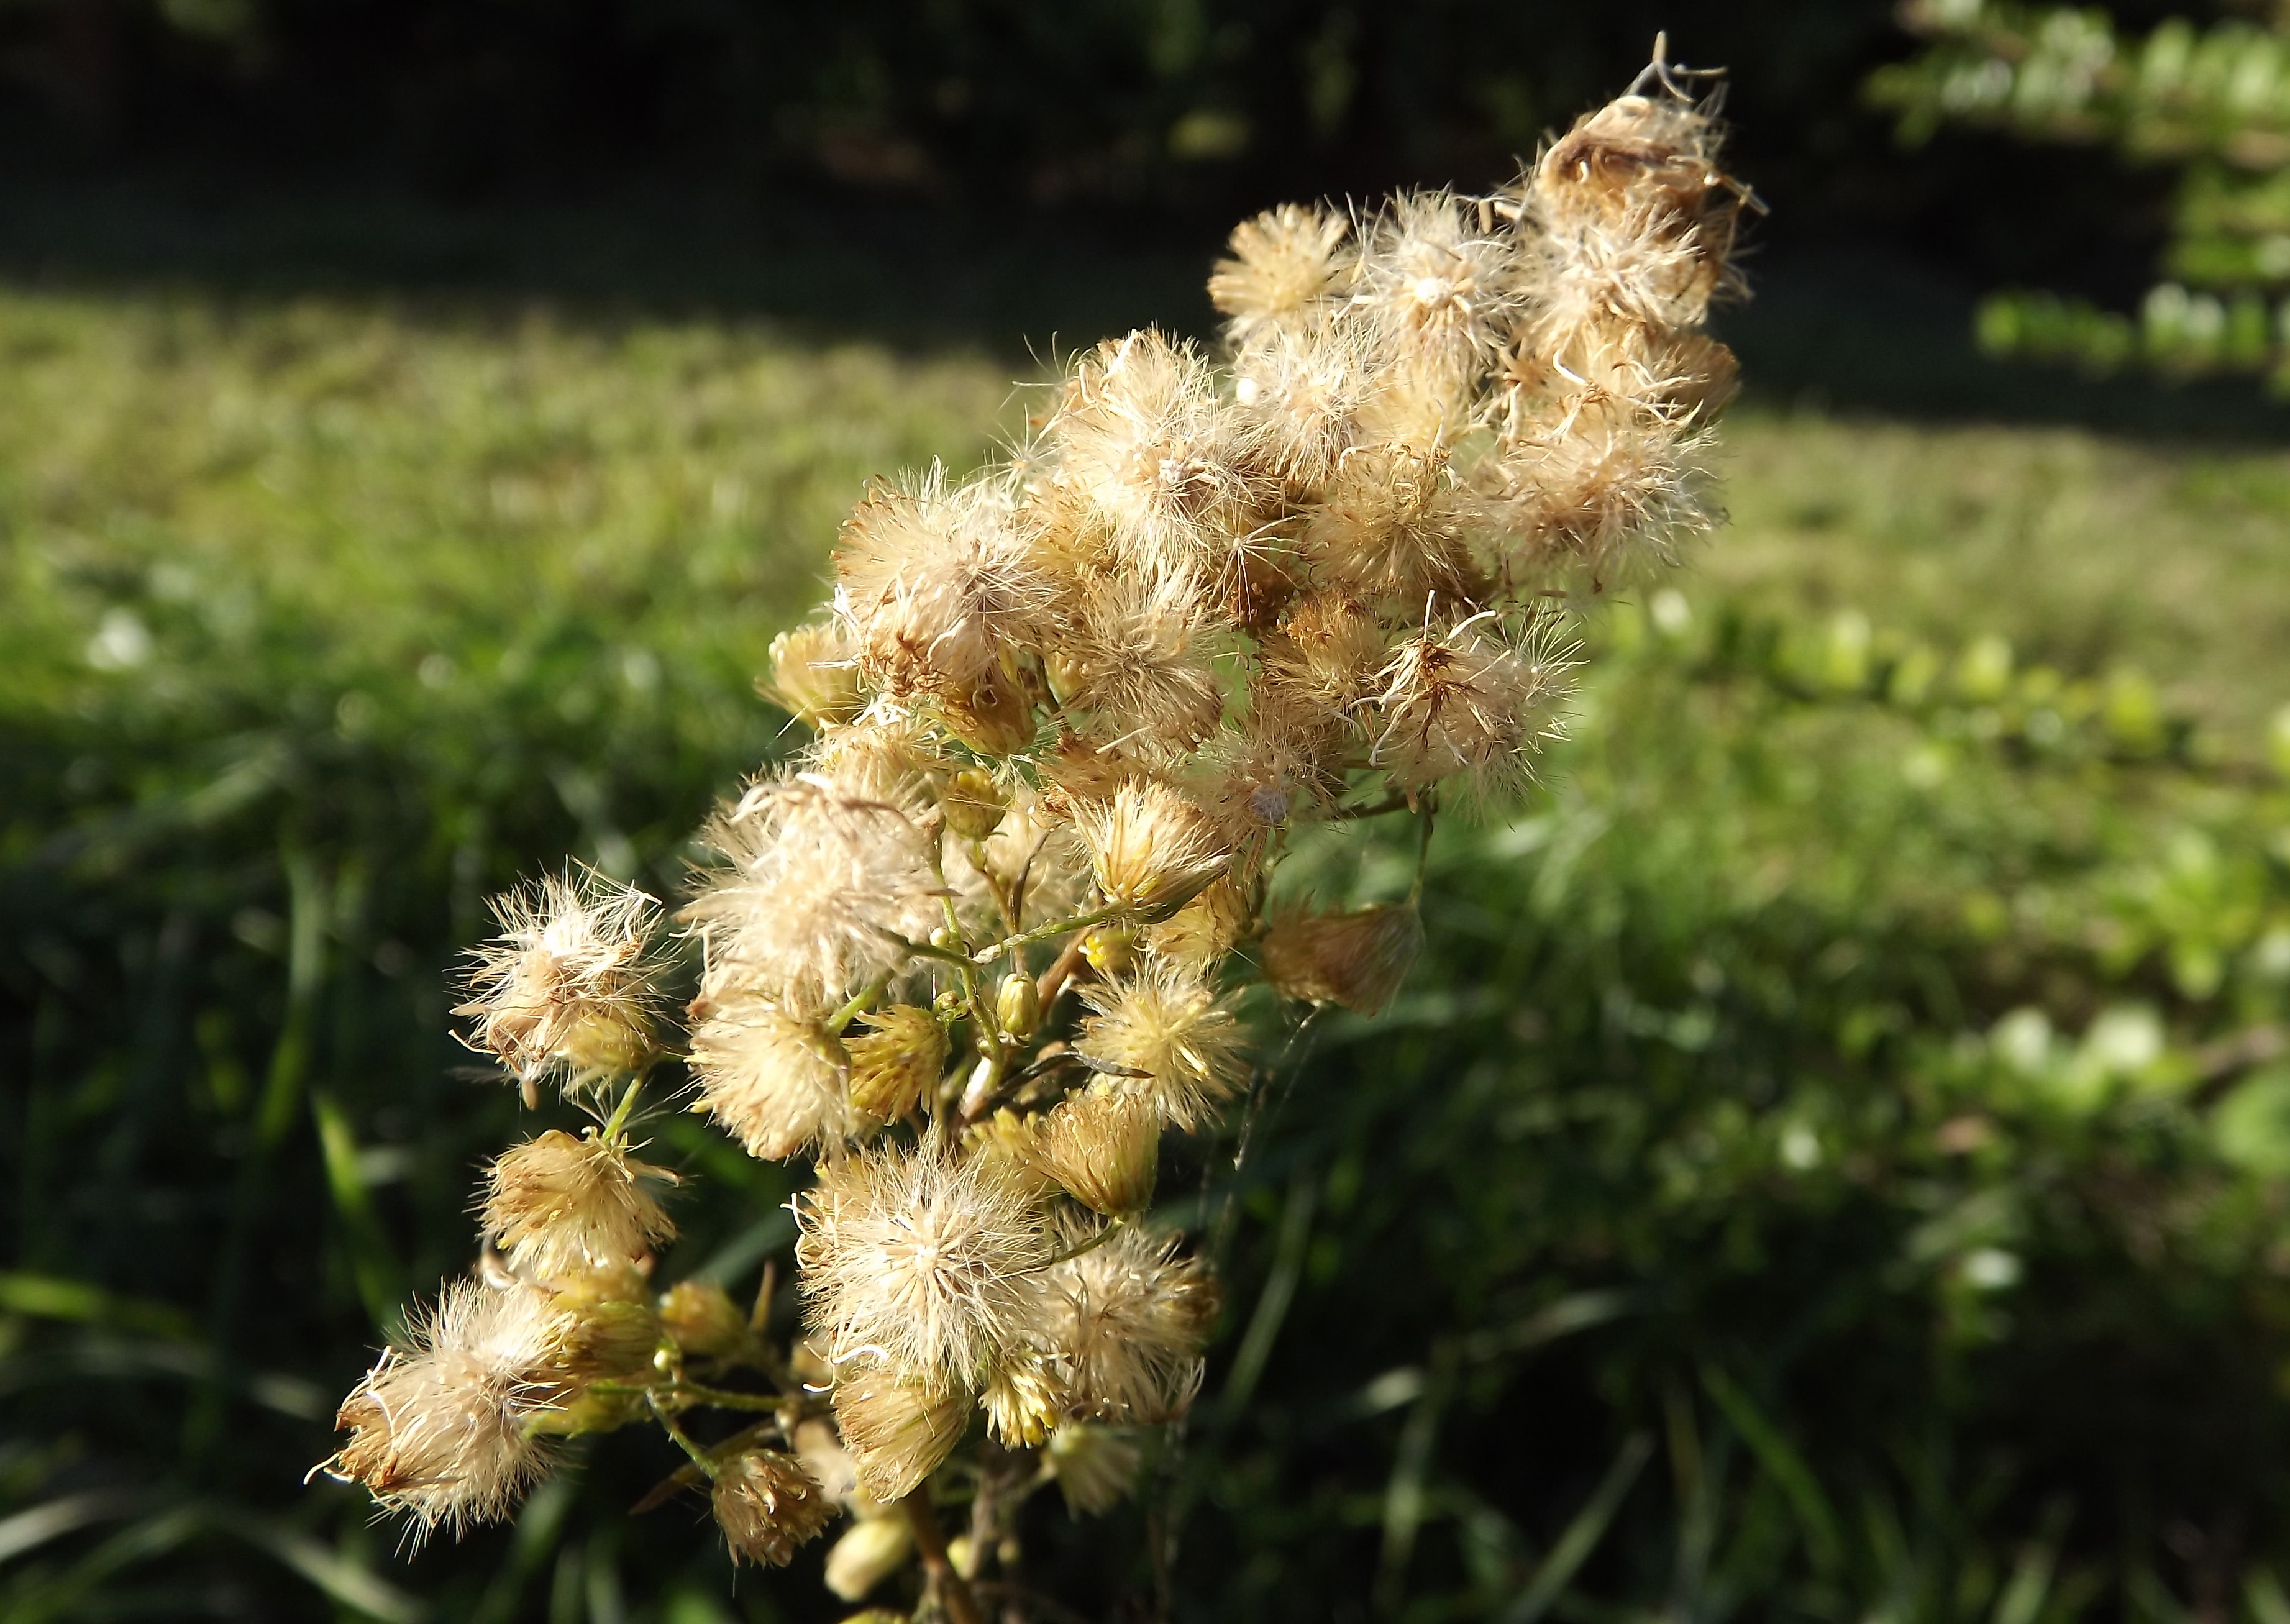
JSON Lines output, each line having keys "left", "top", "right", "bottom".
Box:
{"left": 327, "top": 53, "right": 1747, "bottom": 1620}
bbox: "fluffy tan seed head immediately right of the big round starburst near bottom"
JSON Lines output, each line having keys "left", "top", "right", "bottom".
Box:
{"left": 1044, "top": 1228, "right": 1216, "bottom": 1425}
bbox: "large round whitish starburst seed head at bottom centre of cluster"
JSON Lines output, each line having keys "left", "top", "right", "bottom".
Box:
{"left": 797, "top": 1147, "right": 1049, "bottom": 1390}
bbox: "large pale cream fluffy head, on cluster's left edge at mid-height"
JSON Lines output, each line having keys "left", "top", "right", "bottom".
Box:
{"left": 682, "top": 774, "right": 939, "bottom": 1010}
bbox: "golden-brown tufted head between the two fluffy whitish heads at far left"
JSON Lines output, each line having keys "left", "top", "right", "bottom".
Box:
{"left": 481, "top": 1127, "right": 675, "bottom": 1280}
